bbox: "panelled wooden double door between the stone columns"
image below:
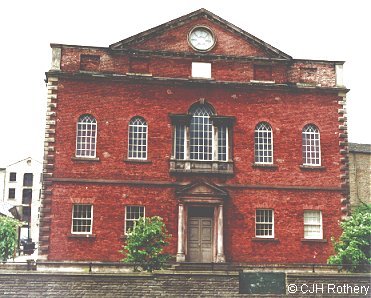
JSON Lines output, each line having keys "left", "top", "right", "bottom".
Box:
{"left": 188, "top": 217, "right": 213, "bottom": 263}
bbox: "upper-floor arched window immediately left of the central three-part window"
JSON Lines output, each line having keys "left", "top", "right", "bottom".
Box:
{"left": 128, "top": 117, "right": 148, "bottom": 159}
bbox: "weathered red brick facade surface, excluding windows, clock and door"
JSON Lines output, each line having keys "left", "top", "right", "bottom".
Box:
{"left": 40, "top": 10, "right": 349, "bottom": 263}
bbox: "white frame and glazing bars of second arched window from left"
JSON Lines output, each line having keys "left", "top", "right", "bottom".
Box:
{"left": 128, "top": 116, "right": 148, "bottom": 160}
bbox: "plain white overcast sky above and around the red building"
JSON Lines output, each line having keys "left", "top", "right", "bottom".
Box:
{"left": 0, "top": 0, "right": 371, "bottom": 167}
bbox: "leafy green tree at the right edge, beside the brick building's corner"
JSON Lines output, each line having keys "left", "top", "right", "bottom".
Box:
{"left": 328, "top": 204, "right": 371, "bottom": 272}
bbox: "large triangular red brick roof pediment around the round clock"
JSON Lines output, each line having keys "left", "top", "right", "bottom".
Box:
{"left": 110, "top": 8, "right": 291, "bottom": 59}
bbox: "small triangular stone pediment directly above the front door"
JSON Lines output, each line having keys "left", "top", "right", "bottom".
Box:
{"left": 176, "top": 181, "right": 228, "bottom": 197}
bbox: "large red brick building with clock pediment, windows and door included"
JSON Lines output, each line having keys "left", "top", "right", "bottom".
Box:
{"left": 40, "top": 9, "right": 348, "bottom": 263}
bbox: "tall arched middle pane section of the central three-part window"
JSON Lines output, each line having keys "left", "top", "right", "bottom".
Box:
{"left": 190, "top": 105, "right": 214, "bottom": 160}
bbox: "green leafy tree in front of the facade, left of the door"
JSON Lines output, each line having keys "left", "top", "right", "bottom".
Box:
{"left": 120, "top": 216, "right": 171, "bottom": 272}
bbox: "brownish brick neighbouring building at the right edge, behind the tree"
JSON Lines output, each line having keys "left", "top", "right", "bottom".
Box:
{"left": 349, "top": 143, "right": 371, "bottom": 209}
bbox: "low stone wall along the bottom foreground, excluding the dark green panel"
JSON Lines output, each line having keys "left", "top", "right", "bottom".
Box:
{"left": 0, "top": 272, "right": 370, "bottom": 297}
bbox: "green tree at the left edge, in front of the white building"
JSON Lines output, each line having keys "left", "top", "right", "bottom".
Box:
{"left": 0, "top": 216, "right": 20, "bottom": 262}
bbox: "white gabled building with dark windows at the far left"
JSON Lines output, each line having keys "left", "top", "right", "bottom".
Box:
{"left": 1, "top": 157, "right": 42, "bottom": 248}
